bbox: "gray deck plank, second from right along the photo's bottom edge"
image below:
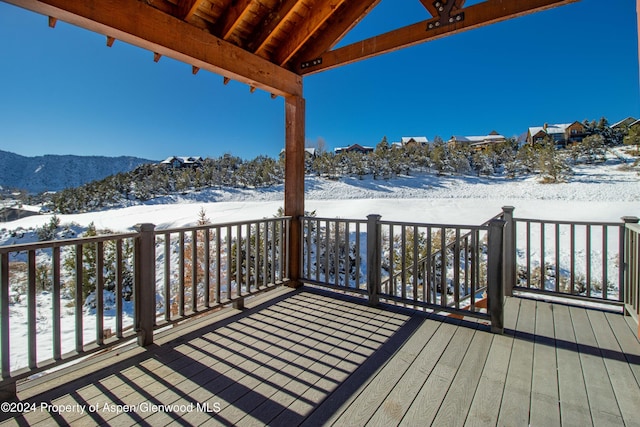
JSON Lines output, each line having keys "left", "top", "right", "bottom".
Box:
{"left": 569, "top": 307, "right": 624, "bottom": 426}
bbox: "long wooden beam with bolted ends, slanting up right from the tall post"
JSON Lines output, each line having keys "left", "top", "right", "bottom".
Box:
{"left": 295, "top": 0, "right": 580, "bottom": 75}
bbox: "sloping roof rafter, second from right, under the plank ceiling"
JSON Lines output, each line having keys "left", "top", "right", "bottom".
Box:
{"left": 274, "top": 0, "right": 346, "bottom": 65}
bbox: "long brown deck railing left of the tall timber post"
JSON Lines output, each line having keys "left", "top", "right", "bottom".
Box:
{"left": 0, "top": 217, "right": 290, "bottom": 397}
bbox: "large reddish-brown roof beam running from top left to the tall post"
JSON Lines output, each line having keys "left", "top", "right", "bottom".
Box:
{"left": 5, "top": 0, "right": 302, "bottom": 96}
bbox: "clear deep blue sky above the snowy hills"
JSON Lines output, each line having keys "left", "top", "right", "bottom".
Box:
{"left": 0, "top": 0, "right": 640, "bottom": 160}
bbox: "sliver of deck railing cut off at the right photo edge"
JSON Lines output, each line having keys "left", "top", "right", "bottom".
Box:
{"left": 623, "top": 218, "right": 640, "bottom": 338}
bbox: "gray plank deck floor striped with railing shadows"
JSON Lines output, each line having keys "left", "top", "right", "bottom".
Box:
{"left": 0, "top": 288, "right": 640, "bottom": 426}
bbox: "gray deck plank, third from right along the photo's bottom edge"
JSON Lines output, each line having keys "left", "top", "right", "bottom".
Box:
{"left": 553, "top": 305, "right": 593, "bottom": 426}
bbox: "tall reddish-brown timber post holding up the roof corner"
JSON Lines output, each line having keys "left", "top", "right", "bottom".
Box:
{"left": 284, "top": 96, "right": 305, "bottom": 287}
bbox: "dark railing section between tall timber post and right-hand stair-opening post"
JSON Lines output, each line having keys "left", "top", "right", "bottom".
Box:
{"left": 301, "top": 215, "right": 504, "bottom": 329}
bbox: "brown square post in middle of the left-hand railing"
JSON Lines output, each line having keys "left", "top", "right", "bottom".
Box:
{"left": 134, "top": 224, "right": 156, "bottom": 347}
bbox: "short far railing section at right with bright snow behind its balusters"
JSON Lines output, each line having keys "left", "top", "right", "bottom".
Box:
{"left": 505, "top": 211, "right": 636, "bottom": 304}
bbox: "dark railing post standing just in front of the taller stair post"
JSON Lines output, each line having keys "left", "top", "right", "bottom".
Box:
{"left": 487, "top": 219, "right": 506, "bottom": 334}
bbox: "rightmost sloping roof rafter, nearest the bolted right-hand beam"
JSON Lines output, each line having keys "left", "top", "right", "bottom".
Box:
{"left": 299, "top": 0, "right": 380, "bottom": 68}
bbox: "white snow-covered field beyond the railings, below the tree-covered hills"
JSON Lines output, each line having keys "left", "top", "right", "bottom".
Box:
{"left": 0, "top": 152, "right": 640, "bottom": 369}
